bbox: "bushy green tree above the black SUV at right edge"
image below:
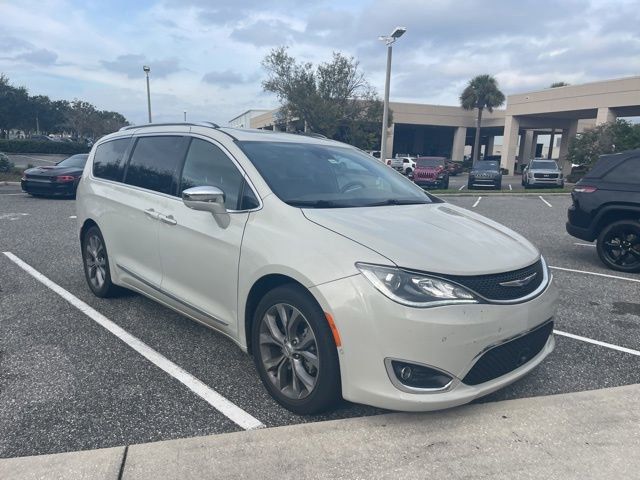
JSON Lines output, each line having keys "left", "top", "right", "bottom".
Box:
{"left": 567, "top": 119, "right": 640, "bottom": 166}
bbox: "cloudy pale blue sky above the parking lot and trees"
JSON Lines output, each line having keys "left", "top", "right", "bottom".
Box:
{"left": 0, "top": 0, "right": 640, "bottom": 125}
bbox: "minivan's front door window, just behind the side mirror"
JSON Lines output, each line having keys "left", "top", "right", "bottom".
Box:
{"left": 180, "top": 138, "right": 248, "bottom": 210}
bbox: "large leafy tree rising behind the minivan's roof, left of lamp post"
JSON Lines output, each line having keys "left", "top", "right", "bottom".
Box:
{"left": 262, "top": 47, "right": 382, "bottom": 149}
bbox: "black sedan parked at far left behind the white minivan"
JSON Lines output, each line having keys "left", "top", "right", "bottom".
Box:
{"left": 20, "top": 153, "right": 89, "bottom": 197}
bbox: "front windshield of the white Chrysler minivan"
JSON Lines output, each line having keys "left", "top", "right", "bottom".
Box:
{"left": 238, "top": 142, "right": 432, "bottom": 208}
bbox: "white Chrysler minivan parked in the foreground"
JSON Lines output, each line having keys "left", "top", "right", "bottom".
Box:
{"left": 77, "top": 122, "right": 557, "bottom": 414}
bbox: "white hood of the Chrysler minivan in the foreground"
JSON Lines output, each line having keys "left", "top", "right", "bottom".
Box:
{"left": 303, "top": 203, "right": 540, "bottom": 275}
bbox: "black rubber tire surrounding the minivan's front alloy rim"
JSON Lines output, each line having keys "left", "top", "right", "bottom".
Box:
{"left": 251, "top": 284, "right": 342, "bottom": 415}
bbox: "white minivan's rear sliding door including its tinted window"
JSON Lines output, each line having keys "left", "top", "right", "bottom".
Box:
{"left": 112, "top": 135, "right": 188, "bottom": 290}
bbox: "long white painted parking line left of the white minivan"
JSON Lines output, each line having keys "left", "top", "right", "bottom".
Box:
{"left": 3, "top": 252, "right": 264, "bottom": 430}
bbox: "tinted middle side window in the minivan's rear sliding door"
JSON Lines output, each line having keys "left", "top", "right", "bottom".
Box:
{"left": 125, "top": 136, "right": 185, "bottom": 194}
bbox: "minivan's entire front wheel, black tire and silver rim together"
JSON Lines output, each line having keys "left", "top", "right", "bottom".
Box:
{"left": 251, "top": 285, "right": 342, "bottom": 415}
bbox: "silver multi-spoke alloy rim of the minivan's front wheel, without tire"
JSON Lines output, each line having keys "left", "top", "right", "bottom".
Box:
{"left": 259, "top": 303, "right": 320, "bottom": 400}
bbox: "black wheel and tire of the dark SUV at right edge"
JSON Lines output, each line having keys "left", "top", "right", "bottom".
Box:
{"left": 596, "top": 220, "right": 640, "bottom": 273}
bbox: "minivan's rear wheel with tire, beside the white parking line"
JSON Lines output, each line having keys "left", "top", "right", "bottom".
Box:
{"left": 82, "top": 226, "right": 122, "bottom": 298}
